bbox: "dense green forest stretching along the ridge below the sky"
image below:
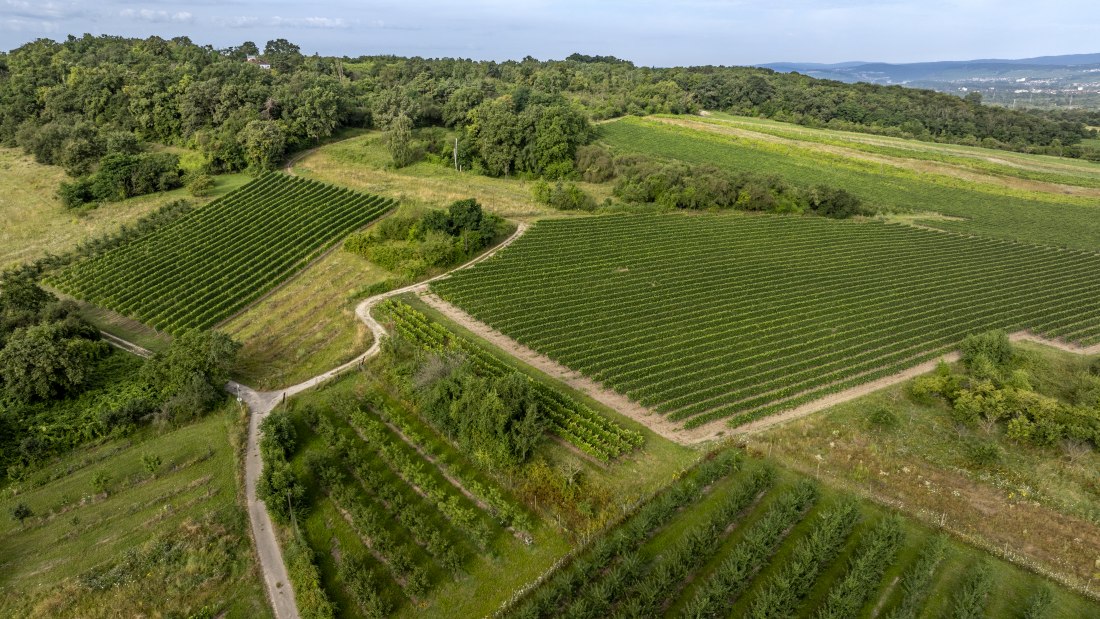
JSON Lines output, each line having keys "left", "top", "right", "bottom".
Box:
{"left": 0, "top": 35, "right": 1098, "bottom": 205}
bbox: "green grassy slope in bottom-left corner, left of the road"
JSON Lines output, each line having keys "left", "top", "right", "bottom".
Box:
{"left": 0, "top": 404, "right": 271, "bottom": 618}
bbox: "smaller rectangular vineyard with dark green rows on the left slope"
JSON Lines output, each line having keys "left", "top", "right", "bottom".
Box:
{"left": 47, "top": 174, "right": 394, "bottom": 333}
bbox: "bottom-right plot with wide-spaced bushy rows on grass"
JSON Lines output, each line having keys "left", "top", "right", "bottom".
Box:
{"left": 502, "top": 451, "right": 1100, "bottom": 619}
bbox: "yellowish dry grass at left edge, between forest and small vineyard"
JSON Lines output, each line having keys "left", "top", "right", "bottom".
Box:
{"left": 0, "top": 148, "right": 248, "bottom": 267}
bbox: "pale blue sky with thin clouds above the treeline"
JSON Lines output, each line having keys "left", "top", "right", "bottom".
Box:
{"left": 0, "top": 0, "right": 1100, "bottom": 66}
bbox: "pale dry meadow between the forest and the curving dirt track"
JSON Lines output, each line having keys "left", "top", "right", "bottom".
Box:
{"left": 294, "top": 132, "right": 611, "bottom": 220}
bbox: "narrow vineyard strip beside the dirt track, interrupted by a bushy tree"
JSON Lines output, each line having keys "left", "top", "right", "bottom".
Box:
{"left": 381, "top": 299, "right": 642, "bottom": 462}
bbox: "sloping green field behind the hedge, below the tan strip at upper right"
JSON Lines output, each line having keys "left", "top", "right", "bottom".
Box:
{"left": 601, "top": 118, "right": 1100, "bottom": 250}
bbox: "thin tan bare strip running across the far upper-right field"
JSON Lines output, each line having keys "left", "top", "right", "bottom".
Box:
{"left": 651, "top": 118, "right": 1100, "bottom": 198}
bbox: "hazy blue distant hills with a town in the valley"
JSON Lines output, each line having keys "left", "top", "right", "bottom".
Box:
{"left": 760, "top": 54, "right": 1100, "bottom": 109}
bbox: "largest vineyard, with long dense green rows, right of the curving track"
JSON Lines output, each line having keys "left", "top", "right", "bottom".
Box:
{"left": 432, "top": 215, "right": 1100, "bottom": 427}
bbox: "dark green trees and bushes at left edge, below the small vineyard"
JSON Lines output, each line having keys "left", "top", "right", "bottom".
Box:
{"left": 0, "top": 269, "right": 240, "bottom": 480}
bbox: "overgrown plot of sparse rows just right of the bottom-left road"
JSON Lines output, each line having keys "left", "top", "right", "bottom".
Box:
{"left": 279, "top": 382, "right": 567, "bottom": 617}
